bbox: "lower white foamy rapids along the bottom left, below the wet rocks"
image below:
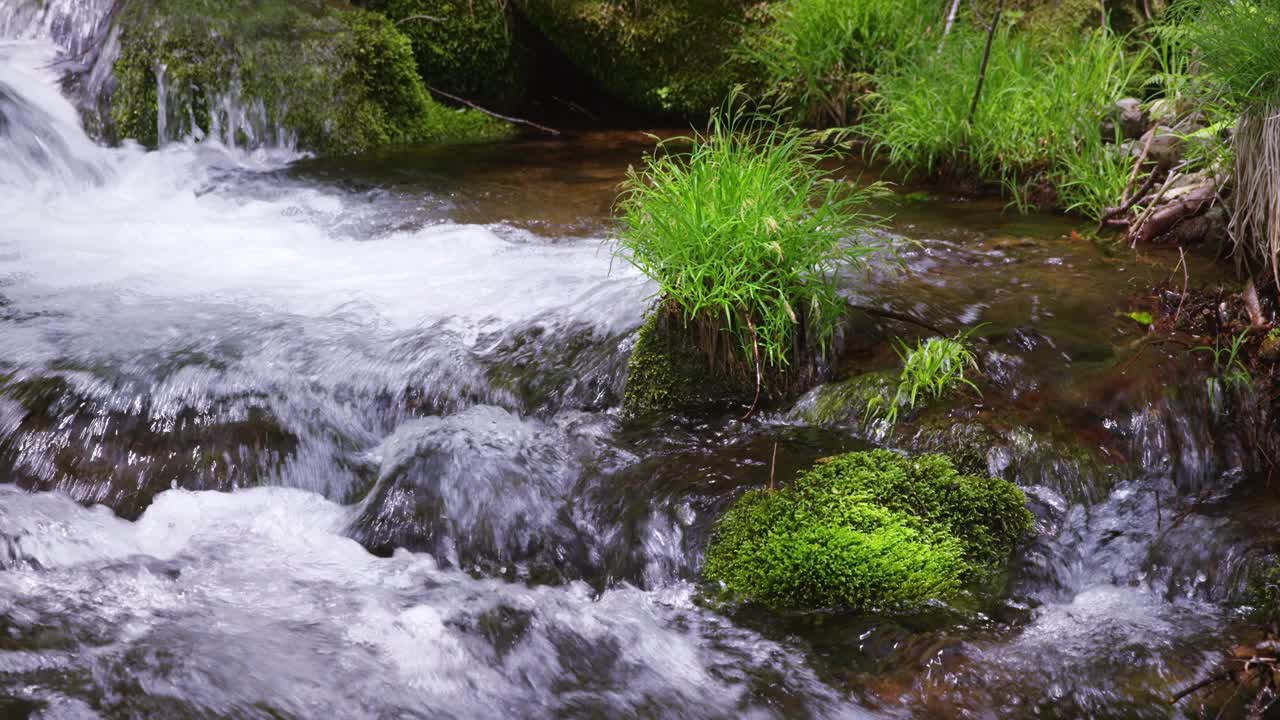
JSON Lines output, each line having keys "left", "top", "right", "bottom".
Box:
{"left": 0, "top": 488, "right": 861, "bottom": 719}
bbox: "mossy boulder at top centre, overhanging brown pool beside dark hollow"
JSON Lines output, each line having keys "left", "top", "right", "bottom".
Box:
{"left": 516, "top": 0, "right": 753, "bottom": 115}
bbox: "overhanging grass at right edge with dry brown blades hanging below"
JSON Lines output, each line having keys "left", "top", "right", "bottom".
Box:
{"left": 1184, "top": 0, "right": 1280, "bottom": 291}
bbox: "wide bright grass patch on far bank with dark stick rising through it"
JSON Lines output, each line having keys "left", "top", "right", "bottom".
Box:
{"left": 861, "top": 28, "right": 1142, "bottom": 214}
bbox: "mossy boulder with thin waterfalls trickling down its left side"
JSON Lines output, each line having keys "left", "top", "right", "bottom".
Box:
{"left": 111, "top": 0, "right": 508, "bottom": 154}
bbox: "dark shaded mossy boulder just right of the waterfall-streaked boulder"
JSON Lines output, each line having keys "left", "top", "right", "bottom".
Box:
{"left": 362, "top": 0, "right": 532, "bottom": 109}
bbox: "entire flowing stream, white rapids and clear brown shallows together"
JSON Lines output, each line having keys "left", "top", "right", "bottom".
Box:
{"left": 0, "top": 0, "right": 1276, "bottom": 717}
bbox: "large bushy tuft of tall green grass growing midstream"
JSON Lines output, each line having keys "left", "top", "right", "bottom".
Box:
{"left": 618, "top": 109, "right": 881, "bottom": 380}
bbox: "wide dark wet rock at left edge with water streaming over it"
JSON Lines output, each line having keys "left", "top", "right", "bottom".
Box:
{"left": 0, "top": 373, "right": 298, "bottom": 518}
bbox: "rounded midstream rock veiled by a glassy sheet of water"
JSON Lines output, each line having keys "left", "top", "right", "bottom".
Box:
{"left": 351, "top": 406, "right": 590, "bottom": 573}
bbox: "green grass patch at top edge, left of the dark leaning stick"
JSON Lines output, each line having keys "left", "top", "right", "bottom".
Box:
{"left": 741, "top": 0, "right": 945, "bottom": 127}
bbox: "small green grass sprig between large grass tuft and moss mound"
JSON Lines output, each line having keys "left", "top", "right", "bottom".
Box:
{"left": 867, "top": 331, "right": 978, "bottom": 427}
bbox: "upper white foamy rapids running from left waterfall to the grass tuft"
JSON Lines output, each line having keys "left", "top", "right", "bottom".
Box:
{"left": 0, "top": 36, "right": 650, "bottom": 407}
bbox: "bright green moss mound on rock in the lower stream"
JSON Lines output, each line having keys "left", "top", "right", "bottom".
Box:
{"left": 703, "top": 450, "right": 1033, "bottom": 609}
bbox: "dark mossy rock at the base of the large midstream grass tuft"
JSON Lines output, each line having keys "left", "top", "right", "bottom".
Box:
{"left": 622, "top": 306, "right": 750, "bottom": 419}
